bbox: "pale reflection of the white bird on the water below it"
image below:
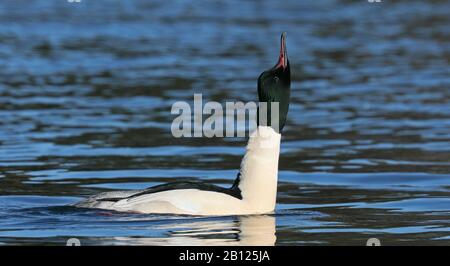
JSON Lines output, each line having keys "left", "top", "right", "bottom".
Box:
{"left": 115, "top": 215, "right": 276, "bottom": 246}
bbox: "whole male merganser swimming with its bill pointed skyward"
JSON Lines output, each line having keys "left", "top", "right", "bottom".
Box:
{"left": 75, "top": 33, "right": 291, "bottom": 215}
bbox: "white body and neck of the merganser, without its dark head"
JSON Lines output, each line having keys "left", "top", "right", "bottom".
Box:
{"left": 76, "top": 126, "right": 281, "bottom": 215}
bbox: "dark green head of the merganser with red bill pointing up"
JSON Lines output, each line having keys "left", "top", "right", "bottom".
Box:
{"left": 258, "top": 32, "right": 291, "bottom": 132}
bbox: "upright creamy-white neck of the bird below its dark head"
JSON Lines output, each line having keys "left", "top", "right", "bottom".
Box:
{"left": 239, "top": 126, "right": 281, "bottom": 212}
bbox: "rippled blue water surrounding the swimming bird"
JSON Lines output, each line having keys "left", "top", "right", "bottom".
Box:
{"left": 0, "top": 0, "right": 450, "bottom": 245}
